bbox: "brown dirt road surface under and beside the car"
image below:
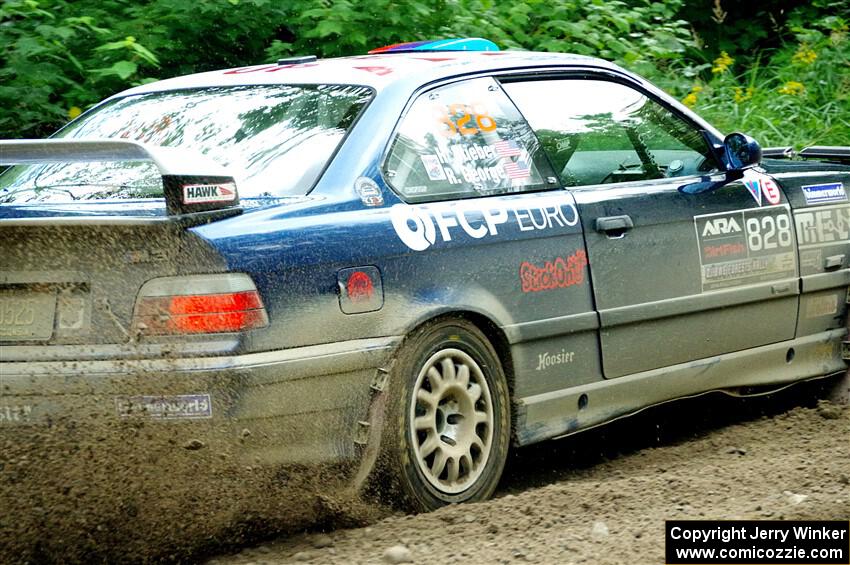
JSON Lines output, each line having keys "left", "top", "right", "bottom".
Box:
{"left": 207, "top": 378, "right": 850, "bottom": 565}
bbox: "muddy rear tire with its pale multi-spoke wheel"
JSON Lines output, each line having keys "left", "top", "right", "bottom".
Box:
{"left": 382, "top": 320, "right": 511, "bottom": 511}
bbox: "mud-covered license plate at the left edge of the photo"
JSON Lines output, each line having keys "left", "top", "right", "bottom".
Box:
{"left": 0, "top": 291, "right": 56, "bottom": 341}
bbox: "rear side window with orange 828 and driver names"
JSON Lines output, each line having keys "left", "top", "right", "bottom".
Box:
{"left": 384, "top": 78, "right": 557, "bottom": 202}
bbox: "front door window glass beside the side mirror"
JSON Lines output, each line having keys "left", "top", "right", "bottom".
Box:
{"left": 502, "top": 79, "right": 718, "bottom": 186}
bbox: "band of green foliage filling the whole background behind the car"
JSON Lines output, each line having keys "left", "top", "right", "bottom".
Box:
{"left": 0, "top": 0, "right": 850, "bottom": 146}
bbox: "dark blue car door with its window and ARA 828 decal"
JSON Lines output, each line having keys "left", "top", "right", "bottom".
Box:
{"left": 503, "top": 74, "right": 799, "bottom": 378}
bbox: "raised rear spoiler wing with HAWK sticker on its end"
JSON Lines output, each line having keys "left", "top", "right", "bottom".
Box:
{"left": 0, "top": 139, "right": 240, "bottom": 215}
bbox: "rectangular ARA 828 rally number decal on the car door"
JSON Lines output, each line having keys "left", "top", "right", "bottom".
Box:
{"left": 694, "top": 205, "right": 797, "bottom": 292}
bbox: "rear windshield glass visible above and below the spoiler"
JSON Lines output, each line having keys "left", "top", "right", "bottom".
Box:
{"left": 0, "top": 85, "right": 372, "bottom": 204}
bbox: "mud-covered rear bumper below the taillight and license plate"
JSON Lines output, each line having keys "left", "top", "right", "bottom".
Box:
{"left": 0, "top": 337, "right": 400, "bottom": 465}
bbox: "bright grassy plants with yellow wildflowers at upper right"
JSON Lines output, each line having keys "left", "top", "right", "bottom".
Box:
{"left": 660, "top": 2, "right": 850, "bottom": 148}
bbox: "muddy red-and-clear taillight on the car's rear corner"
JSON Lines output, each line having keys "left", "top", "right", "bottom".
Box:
{"left": 133, "top": 273, "right": 269, "bottom": 335}
